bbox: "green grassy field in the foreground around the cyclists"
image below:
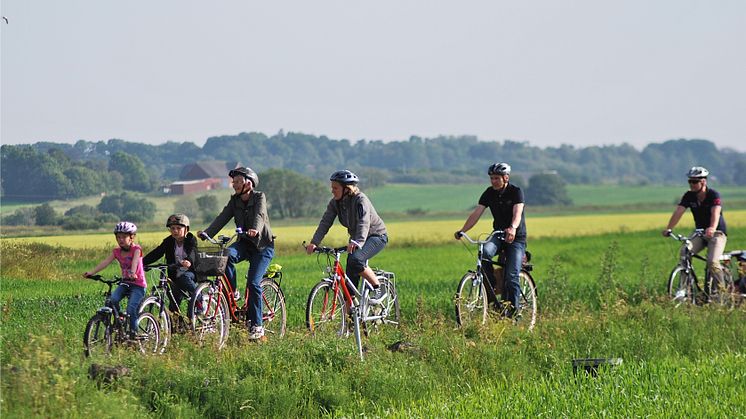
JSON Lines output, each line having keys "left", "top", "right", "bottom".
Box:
{"left": 0, "top": 223, "right": 746, "bottom": 418}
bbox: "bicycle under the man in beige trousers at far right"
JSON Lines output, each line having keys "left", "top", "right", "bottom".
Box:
{"left": 668, "top": 229, "right": 746, "bottom": 307}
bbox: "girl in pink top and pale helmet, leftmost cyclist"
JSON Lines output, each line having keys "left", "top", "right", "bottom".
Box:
{"left": 83, "top": 221, "right": 148, "bottom": 333}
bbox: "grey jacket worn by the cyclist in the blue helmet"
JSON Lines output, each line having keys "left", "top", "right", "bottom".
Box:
{"left": 311, "top": 192, "right": 386, "bottom": 247}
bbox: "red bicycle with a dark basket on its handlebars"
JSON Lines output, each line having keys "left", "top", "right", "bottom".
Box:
{"left": 189, "top": 227, "right": 287, "bottom": 349}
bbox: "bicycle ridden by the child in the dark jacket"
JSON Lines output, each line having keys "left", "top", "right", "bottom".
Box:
{"left": 139, "top": 264, "right": 191, "bottom": 352}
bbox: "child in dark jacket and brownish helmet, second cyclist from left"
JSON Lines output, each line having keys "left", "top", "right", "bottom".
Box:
{"left": 143, "top": 214, "right": 197, "bottom": 310}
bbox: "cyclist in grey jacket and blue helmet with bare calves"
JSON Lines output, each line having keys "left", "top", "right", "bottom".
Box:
{"left": 306, "top": 170, "right": 388, "bottom": 299}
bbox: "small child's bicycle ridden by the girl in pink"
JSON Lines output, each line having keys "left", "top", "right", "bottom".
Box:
{"left": 83, "top": 275, "right": 160, "bottom": 357}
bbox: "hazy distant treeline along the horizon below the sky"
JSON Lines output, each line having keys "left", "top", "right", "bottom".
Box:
{"left": 1, "top": 132, "right": 746, "bottom": 197}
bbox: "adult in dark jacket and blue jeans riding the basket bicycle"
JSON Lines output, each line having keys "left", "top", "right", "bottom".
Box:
{"left": 198, "top": 167, "right": 275, "bottom": 340}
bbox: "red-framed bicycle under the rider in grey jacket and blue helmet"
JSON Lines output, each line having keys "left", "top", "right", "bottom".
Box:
{"left": 303, "top": 242, "right": 401, "bottom": 359}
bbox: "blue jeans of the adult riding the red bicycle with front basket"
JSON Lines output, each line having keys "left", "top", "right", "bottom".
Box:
{"left": 225, "top": 240, "right": 275, "bottom": 326}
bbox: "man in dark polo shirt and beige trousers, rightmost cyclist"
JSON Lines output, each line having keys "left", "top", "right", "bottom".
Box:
{"left": 663, "top": 166, "right": 727, "bottom": 283}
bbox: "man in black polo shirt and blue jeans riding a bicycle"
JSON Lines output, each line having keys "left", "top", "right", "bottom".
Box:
{"left": 455, "top": 163, "right": 526, "bottom": 315}
